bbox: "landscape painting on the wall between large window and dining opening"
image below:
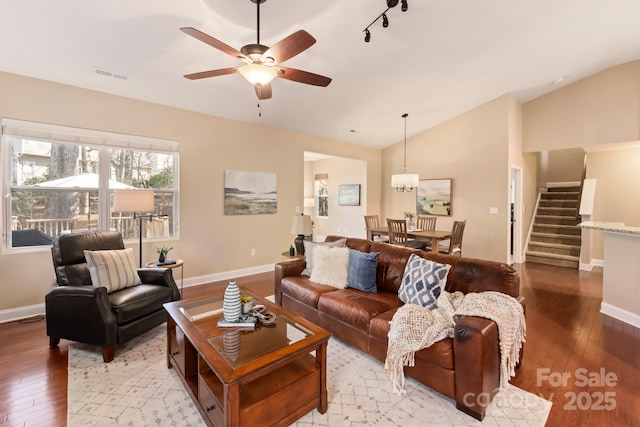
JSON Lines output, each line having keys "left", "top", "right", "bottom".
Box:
{"left": 224, "top": 170, "right": 278, "bottom": 215}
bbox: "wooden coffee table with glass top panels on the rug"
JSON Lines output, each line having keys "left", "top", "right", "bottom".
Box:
{"left": 164, "top": 291, "right": 331, "bottom": 427}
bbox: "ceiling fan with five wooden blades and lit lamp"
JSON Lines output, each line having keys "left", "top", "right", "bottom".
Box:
{"left": 180, "top": 0, "right": 331, "bottom": 99}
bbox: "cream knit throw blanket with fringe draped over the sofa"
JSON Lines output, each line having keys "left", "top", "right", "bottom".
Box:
{"left": 384, "top": 291, "right": 526, "bottom": 394}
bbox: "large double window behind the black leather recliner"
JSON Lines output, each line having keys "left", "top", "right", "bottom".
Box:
{"left": 2, "top": 119, "right": 178, "bottom": 249}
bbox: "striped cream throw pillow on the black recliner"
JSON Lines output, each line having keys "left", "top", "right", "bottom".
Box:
{"left": 84, "top": 248, "right": 140, "bottom": 292}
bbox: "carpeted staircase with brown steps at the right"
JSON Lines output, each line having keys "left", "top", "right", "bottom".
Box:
{"left": 526, "top": 186, "right": 581, "bottom": 269}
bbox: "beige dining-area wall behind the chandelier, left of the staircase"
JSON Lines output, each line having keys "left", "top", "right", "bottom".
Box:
{"left": 381, "top": 96, "right": 524, "bottom": 262}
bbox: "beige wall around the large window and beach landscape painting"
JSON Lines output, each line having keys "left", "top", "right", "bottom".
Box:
{"left": 0, "top": 73, "right": 381, "bottom": 310}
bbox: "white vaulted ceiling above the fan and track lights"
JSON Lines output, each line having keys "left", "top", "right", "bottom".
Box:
{"left": 0, "top": 0, "right": 640, "bottom": 148}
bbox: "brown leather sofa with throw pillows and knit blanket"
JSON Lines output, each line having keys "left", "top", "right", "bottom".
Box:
{"left": 275, "top": 236, "right": 524, "bottom": 420}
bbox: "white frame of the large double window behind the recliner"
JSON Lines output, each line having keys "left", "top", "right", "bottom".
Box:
{"left": 0, "top": 118, "right": 180, "bottom": 253}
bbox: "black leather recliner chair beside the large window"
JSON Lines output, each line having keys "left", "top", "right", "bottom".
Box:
{"left": 45, "top": 231, "right": 180, "bottom": 362}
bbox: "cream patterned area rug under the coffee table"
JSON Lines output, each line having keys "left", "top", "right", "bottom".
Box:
{"left": 68, "top": 325, "right": 551, "bottom": 427}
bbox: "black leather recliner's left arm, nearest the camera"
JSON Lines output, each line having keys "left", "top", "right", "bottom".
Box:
{"left": 45, "top": 285, "right": 117, "bottom": 347}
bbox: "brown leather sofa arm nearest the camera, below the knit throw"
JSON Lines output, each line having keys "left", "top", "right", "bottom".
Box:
{"left": 453, "top": 316, "right": 500, "bottom": 420}
